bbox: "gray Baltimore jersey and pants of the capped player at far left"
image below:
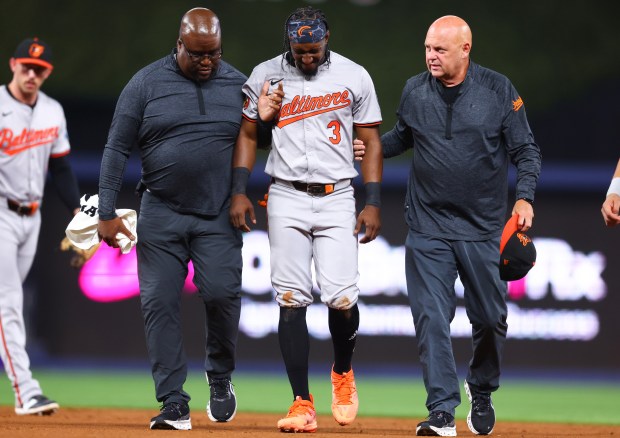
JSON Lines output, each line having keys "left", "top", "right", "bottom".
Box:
{"left": 0, "top": 86, "right": 70, "bottom": 407}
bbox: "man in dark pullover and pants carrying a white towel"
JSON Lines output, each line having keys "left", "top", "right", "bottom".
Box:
{"left": 98, "top": 8, "right": 247, "bottom": 430}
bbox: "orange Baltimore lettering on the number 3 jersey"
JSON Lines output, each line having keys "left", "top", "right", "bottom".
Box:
{"left": 276, "top": 90, "right": 351, "bottom": 128}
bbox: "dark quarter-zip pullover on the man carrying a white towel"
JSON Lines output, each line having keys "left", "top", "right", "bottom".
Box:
{"left": 99, "top": 53, "right": 247, "bottom": 220}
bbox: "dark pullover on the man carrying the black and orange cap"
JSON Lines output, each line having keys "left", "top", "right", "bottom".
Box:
{"left": 381, "top": 62, "right": 541, "bottom": 241}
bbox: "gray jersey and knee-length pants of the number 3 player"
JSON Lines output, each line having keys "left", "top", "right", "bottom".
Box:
{"left": 243, "top": 52, "right": 381, "bottom": 309}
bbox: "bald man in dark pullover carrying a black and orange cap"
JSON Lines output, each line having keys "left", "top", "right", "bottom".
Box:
{"left": 381, "top": 16, "right": 541, "bottom": 436}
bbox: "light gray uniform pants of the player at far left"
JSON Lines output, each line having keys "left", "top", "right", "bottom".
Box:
{"left": 0, "top": 204, "right": 41, "bottom": 407}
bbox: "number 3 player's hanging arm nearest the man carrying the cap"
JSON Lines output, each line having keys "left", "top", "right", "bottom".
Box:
{"left": 354, "top": 126, "right": 383, "bottom": 243}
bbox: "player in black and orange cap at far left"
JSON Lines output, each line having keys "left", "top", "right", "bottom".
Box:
{"left": 0, "top": 38, "right": 80, "bottom": 415}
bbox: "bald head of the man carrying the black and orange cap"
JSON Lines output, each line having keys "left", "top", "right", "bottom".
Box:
{"left": 424, "top": 15, "right": 472, "bottom": 87}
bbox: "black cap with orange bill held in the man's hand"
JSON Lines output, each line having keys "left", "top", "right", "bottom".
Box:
{"left": 499, "top": 214, "right": 536, "bottom": 281}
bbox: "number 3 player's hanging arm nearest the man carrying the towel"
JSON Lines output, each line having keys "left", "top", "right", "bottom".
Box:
{"left": 229, "top": 118, "right": 258, "bottom": 231}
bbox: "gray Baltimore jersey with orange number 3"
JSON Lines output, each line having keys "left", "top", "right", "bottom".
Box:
{"left": 243, "top": 52, "right": 381, "bottom": 183}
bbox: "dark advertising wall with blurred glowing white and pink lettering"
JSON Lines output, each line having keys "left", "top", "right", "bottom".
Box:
{"left": 27, "top": 181, "right": 620, "bottom": 371}
